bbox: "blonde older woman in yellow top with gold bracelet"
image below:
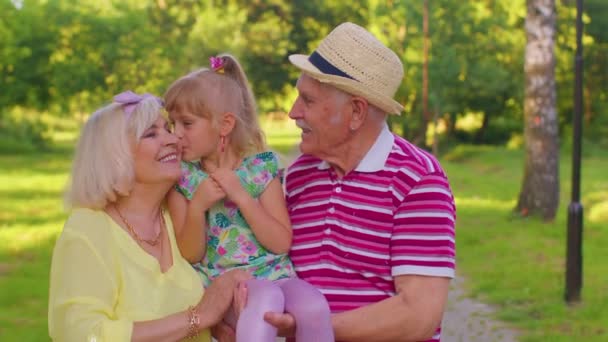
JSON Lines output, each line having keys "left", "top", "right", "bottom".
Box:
{"left": 49, "top": 92, "right": 248, "bottom": 342}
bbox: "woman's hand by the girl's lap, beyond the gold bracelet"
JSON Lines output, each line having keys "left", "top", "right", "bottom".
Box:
{"left": 197, "top": 269, "right": 252, "bottom": 328}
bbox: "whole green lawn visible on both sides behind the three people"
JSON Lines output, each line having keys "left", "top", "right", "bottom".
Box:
{"left": 0, "top": 122, "right": 608, "bottom": 341}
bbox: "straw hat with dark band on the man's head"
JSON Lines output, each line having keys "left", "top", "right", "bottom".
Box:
{"left": 289, "top": 23, "right": 403, "bottom": 114}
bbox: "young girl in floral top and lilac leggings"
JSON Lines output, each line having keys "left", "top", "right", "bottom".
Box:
{"left": 165, "top": 55, "right": 334, "bottom": 342}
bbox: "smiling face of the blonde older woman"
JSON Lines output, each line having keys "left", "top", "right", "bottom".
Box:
{"left": 134, "top": 116, "right": 181, "bottom": 183}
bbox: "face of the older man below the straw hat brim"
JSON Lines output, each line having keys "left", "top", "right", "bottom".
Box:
{"left": 289, "top": 74, "right": 350, "bottom": 159}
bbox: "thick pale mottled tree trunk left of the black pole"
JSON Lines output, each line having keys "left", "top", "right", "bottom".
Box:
{"left": 516, "top": 0, "right": 559, "bottom": 220}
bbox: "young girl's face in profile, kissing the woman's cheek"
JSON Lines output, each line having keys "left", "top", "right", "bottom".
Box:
{"left": 169, "top": 111, "right": 220, "bottom": 161}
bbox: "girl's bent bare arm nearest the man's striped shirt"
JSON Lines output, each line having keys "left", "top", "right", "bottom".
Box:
{"left": 211, "top": 169, "right": 292, "bottom": 254}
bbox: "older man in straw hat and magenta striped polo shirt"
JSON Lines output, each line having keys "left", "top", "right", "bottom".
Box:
{"left": 265, "top": 23, "right": 455, "bottom": 341}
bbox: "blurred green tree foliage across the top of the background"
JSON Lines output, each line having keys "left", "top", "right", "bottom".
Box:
{"left": 0, "top": 0, "right": 608, "bottom": 152}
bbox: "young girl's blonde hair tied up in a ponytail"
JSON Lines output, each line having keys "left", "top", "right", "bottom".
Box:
{"left": 164, "top": 54, "right": 266, "bottom": 157}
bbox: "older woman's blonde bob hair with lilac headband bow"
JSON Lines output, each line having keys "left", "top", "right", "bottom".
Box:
{"left": 65, "top": 97, "right": 162, "bottom": 209}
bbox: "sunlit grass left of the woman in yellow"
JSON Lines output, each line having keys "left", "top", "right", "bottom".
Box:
{"left": 0, "top": 145, "right": 71, "bottom": 341}
